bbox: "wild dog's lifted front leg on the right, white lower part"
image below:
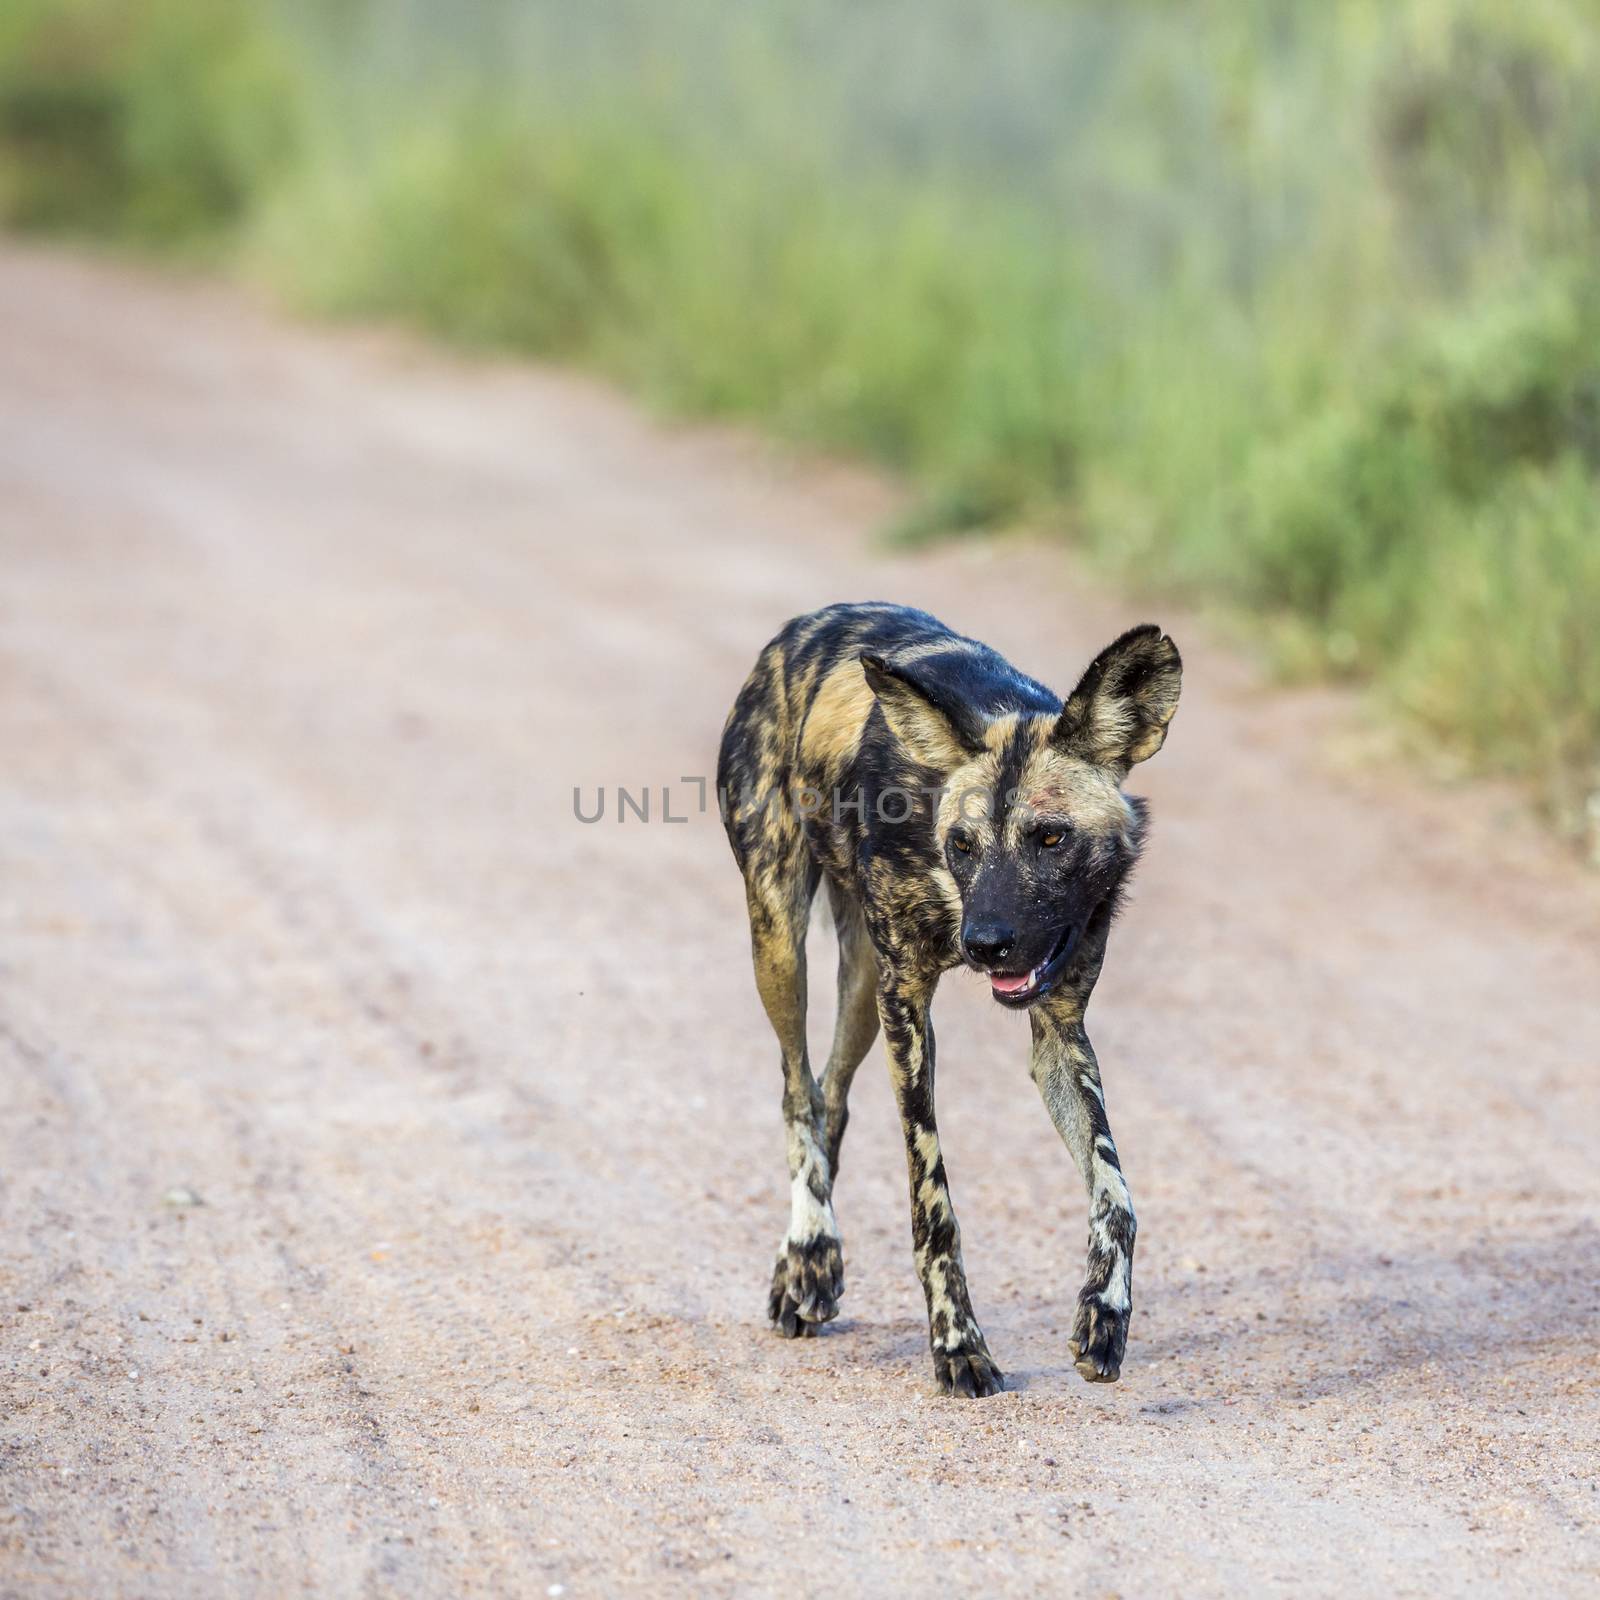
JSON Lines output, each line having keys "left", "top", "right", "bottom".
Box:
{"left": 1029, "top": 997, "right": 1134, "bottom": 1384}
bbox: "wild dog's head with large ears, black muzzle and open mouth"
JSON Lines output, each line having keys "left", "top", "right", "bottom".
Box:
{"left": 862, "top": 624, "right": 1182, "bottom": 1008}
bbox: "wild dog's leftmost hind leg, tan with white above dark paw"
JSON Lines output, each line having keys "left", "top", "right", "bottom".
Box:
{"left": 744, "top": 818, "right": 845, "bottom": 1339}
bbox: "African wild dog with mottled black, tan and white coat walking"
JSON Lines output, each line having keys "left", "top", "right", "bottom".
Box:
{"left": 717, "top": 603, "right": 1182, "bottom": 1395}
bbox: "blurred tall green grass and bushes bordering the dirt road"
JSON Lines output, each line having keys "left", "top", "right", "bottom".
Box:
{"left": 0, "top": 0, "right": 1600, "bottom": 829}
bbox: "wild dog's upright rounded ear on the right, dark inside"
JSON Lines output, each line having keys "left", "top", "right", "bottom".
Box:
{"left": 1053, "top": 622, "right": 1184, "bottom": 782}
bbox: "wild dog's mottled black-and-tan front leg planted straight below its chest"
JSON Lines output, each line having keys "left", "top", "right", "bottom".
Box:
{"left": 878, "top": 976, "right": 1005, "bottom": 1397}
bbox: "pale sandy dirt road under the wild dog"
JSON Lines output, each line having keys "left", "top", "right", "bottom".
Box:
{"left": 0, "top": 250, "right": 1600, "bottom": 1600}
